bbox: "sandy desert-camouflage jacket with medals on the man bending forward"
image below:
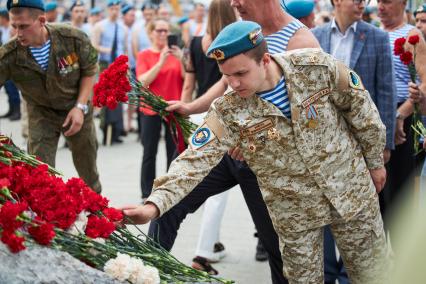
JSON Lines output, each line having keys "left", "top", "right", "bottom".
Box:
{"left": 148, "top": 49, "right": 386, "bottom": 231}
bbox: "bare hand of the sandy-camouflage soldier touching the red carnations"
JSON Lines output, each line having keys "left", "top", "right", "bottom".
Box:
{"left": 120, "top": 203, "right": 160, "bottom": 225}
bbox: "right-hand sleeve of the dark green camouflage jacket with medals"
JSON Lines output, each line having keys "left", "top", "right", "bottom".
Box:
{"left": 79, "top": 33, "right": 98, "bottom": 77}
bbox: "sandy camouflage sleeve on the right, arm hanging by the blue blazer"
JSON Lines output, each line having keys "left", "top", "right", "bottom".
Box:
{"left": 331, "top": 61, "right": 386, "bottom": 169}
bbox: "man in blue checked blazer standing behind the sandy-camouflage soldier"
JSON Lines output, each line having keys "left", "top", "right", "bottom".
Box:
{"left": 312, "top": 0, "right": 396, "bottom": 283}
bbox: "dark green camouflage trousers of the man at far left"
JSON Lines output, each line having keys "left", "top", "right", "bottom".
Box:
{"left": 27, "top": 104, "right": 102, "bottom": 193}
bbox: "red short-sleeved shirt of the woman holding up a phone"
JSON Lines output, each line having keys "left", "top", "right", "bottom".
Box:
{"left": 136, "top": 49, "right": 183, "bottom": 115}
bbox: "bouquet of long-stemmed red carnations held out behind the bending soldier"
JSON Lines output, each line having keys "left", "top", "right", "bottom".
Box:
{"left": 93, "top": 55, "right": 197, "bottom": 153}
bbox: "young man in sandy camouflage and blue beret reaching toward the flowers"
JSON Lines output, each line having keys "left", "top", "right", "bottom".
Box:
{"left": 124, "top": 21, "right": 387, "bottom": 284}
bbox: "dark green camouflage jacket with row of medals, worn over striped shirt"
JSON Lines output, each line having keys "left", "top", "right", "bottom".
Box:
{"left": 0, "top": 24, "right": 98, "bottom": 110}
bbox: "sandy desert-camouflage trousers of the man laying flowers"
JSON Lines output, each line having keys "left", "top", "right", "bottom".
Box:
{"left": 277, "top": 199, "right": 389, "bottom": 284}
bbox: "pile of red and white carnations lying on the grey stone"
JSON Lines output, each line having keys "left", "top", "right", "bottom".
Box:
{"left": 0, "top": 134, "right": 233, "bottom": 284}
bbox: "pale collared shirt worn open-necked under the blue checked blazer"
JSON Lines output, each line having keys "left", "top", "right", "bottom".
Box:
{"left": 330, "top": 19, "right": 358, "bottom": 66}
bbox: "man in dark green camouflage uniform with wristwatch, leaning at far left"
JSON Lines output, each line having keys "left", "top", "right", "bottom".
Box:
{"left": 0, "top": 0, "right": 101, "bottom": 192}
